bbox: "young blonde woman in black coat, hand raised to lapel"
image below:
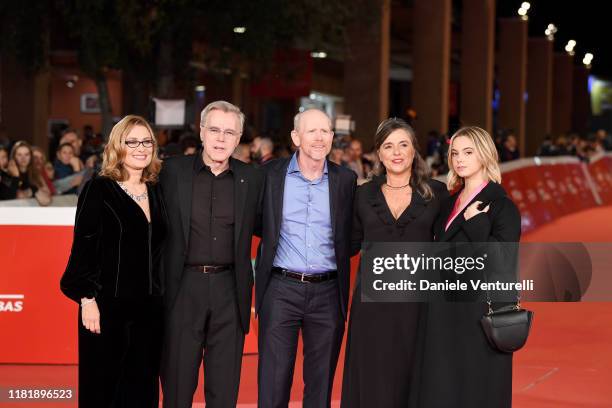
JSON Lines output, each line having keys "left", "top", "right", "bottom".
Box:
{"left": 411, "top": 127, "right": 521, "bottom": 408}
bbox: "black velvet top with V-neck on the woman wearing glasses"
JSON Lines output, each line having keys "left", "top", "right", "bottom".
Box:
{"left": 60, "top": 177, "right": 167, "bottom": 302}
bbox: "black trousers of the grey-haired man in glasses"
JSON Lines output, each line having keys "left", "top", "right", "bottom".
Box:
{"left": 162, "top": 268, "right": 244, "bottom": 408}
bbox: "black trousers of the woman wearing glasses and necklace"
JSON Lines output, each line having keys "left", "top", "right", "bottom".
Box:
{"left": 78, "top": 296, "right": 163, "bottom": 408}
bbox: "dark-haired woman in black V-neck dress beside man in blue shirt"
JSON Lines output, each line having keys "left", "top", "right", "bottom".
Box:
{"left": 341, "top": 118, "right": 448, "bottom": 408}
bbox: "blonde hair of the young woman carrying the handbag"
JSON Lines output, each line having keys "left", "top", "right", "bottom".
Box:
{"left": 446, "top": 126, "right": 501, "bottom": 191}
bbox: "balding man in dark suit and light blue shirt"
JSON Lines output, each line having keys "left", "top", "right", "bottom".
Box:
{"left": 255, "top": 109, "right": 356, "bottom": 408}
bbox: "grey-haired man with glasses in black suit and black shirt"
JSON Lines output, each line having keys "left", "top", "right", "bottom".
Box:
{"left": 160, "top": 101, "right": 263, "bottom": 408}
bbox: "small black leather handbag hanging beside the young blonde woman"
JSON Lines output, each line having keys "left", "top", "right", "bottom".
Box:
{"left": 480, "top": 293, "right": 533, "bottom": 353}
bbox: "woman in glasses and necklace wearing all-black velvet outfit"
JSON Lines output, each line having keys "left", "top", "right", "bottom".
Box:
{"left": 61, "top": 115, "right": 167, "bottom": 408}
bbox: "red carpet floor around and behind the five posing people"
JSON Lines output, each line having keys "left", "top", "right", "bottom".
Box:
{"left": 0, "top": 207, "right": 612, "bottom": 408}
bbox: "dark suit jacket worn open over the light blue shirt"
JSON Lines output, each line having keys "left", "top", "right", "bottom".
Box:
{"left": 255, "top": 158, "right": 357, "bottom": 318}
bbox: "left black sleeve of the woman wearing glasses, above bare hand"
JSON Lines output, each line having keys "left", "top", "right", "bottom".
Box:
{"left": 60, "top": 179, "right": 103, "bottom": 302}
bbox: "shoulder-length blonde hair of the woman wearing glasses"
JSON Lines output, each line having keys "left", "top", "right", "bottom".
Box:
{"left": 100, "top": 115, "right": 161, "bottom": 183}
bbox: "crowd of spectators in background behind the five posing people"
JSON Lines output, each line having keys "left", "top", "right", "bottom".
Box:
{"left": 0, "top": 119, "right": 612, "bottom": 206}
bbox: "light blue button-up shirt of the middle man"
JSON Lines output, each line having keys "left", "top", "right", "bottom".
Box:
{"left": 274, "top": 153, "right": 336, "bottom": 274}
